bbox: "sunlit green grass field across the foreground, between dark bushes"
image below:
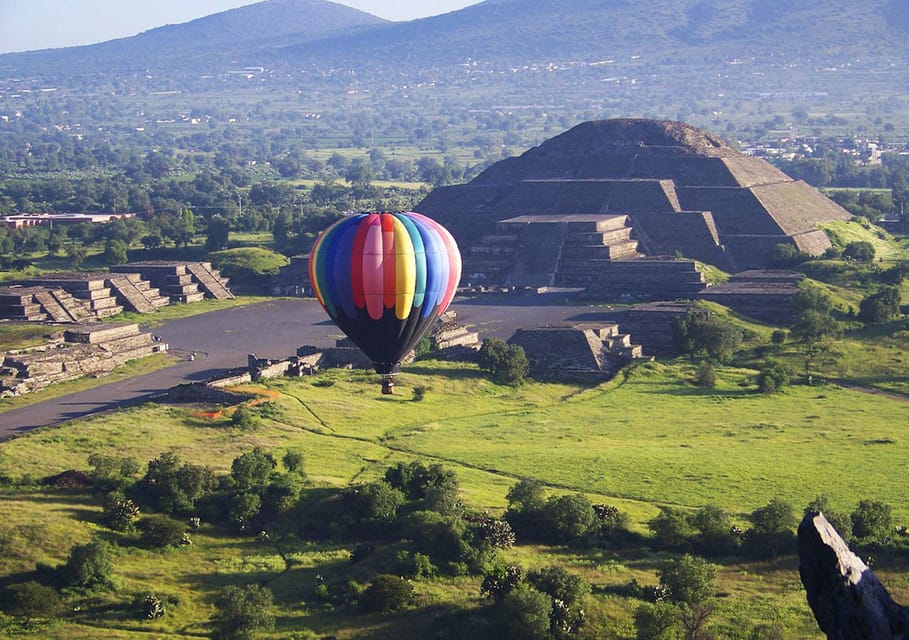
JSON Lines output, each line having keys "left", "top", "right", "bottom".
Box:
{"left": 0, "top": 361, "right": 909, "bottom": 639}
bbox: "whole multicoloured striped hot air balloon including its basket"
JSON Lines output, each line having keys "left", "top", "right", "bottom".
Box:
{"left": 309, "top": 212, "right": 461, "bottom": 394}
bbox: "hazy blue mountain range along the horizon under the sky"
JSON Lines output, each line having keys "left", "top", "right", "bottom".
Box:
{"left": 0, "top": 0, "right": 909, "bottom": 77}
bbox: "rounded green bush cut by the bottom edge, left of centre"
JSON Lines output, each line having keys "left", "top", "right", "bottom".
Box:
{"left": 212, "top": 584, "right": 275, "bottom": 640}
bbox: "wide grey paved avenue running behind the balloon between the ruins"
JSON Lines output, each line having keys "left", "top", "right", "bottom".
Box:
{"left": 0, "top": 296, "right": 608, "bottom": 440}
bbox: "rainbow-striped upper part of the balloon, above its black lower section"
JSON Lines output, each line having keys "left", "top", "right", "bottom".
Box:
{"left": 309, "top": 212, "right": 461, "bottom": 320}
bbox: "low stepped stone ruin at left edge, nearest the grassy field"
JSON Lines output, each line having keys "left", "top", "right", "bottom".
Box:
{"left": 0, "top": 324, "right": 167, "bottom": 396}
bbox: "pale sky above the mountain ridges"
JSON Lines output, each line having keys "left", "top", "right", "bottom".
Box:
{"left": 0, "top": 0, "right": 479, "bottom": 53}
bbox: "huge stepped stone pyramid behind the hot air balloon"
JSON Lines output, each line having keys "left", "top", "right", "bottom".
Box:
{"left": 416, "top": 119, "right": 850, "bottom": 292}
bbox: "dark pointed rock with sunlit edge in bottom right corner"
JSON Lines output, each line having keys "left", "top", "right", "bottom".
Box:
{"left": 798, "top": 513, "right": 909, "bottom": 640}
